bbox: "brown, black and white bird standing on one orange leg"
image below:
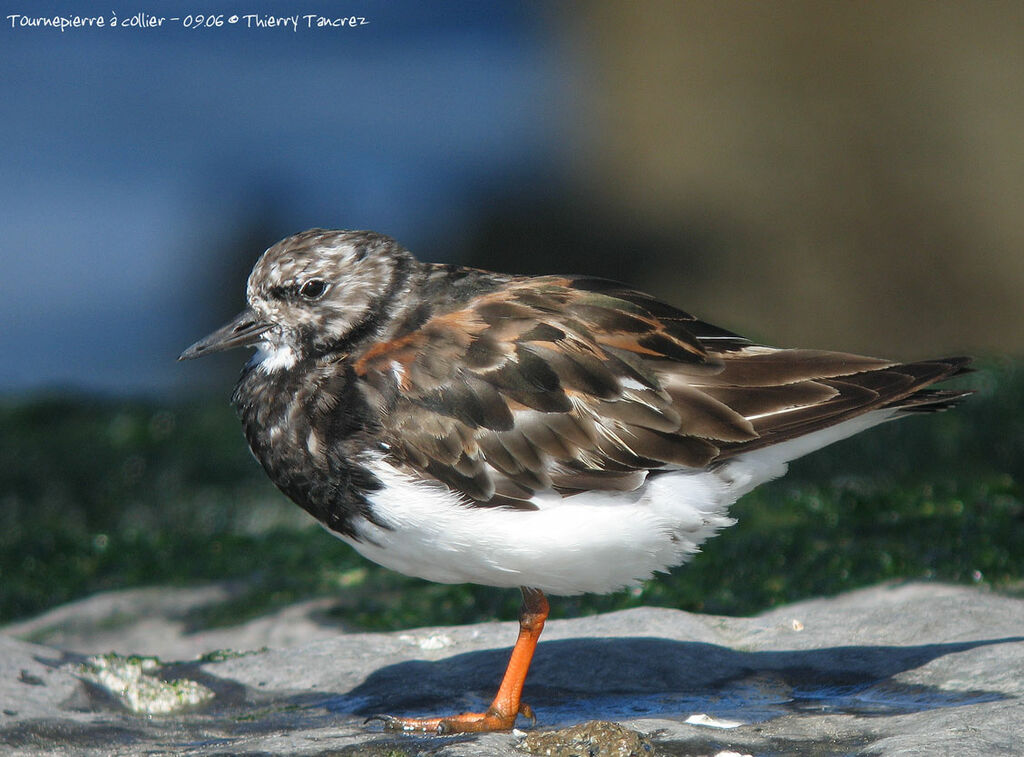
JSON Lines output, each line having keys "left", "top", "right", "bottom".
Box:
{"left": 179, "top": 228, "right": 971, "bottom": 733}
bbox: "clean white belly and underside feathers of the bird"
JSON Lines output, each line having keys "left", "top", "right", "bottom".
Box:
{"left": 333, "top": 411, "right": 895, "bottom": 594}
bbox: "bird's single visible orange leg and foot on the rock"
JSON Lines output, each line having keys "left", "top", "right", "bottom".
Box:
{"left": 370, "top": 586, "right": 548, "bottom": 733}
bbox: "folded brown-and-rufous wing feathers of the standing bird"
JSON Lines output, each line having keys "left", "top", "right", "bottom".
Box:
{"left": 354, "top": 277, "right": 965, "bottom": 506}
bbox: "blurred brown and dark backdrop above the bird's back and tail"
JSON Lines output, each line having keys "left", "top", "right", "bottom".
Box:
{"left": 483, "top": 1, "right": 1024, "bottom": 356}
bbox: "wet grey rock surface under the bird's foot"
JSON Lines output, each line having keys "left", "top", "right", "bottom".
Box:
{"left": 0, "top": 584, "right": 1024, "bottom": 757}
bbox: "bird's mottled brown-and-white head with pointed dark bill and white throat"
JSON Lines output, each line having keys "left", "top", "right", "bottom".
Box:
{"left": 179, "top": 228, "right": 413, "bottom": 370}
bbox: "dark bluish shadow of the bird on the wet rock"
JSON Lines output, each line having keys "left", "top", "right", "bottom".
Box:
{"left": 324, "top": 637, "right": 1024, "bottom": 726}
